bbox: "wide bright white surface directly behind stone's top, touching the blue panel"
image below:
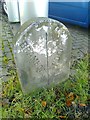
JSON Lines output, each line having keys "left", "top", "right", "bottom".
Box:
{"left": 19, "top": 0, "right": 48, "bottom": 25}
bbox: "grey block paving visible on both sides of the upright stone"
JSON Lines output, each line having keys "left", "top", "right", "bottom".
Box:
{"left": 0, "top": 2, "right": 88, "bottom": 81}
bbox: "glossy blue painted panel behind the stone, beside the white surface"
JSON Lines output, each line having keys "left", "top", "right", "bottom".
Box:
{"left": 49, "top": 2, "right": 90, "bottom": 27}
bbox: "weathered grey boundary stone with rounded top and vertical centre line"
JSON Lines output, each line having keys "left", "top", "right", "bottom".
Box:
{"left": 14, "top": 18, "right": 71, "bottom": 91}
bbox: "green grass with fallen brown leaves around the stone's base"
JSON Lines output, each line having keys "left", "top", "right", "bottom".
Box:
{"left": 1, "top": 44, "right": 89, "bottom": 120}
